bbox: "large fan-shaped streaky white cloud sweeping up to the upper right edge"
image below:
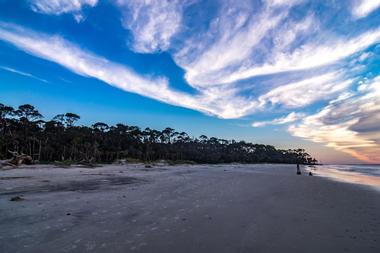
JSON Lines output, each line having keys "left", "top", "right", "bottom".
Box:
{"left": 173, "top": 0, "right": 380, "bottom": 89}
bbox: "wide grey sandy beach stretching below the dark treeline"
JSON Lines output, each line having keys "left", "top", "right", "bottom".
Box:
{"left": 0, "top": 164, "right": 380, "bottom": 253}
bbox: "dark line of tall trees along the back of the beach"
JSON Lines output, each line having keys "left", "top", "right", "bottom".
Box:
{"left": 0, "top": 103, "right": 317, "bottom": 164}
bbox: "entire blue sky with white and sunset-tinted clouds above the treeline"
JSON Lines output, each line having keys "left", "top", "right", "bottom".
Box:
{"left": 0, "top": 0, "right": 380, "bottom": 163}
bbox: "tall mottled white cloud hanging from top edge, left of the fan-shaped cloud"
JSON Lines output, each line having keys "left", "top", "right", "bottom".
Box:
{"left": 117, "top": 0, "right": 184, "bottom": 53}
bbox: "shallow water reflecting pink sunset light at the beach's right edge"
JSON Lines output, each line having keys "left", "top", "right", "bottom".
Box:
{"left": 307, "top": 165, "right": 380, "bottom": 190}
